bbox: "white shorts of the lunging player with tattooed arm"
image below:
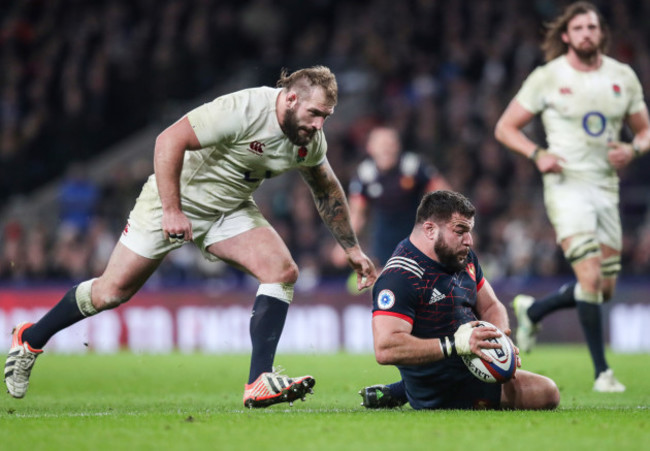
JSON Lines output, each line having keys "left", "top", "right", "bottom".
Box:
{"left": 120, "top": 196, "right": 271, "bottom": 261}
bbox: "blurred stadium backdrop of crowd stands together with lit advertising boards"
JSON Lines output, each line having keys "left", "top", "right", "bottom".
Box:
{"left": 0, "top": 0, "right": 650, "bottom": 352}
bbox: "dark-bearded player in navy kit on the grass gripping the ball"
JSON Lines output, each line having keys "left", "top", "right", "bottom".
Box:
{"left": 360, "top": 191, "right": 560, "bottom": 409}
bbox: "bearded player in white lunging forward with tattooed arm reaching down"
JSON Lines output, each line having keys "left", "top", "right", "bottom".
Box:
{"left": 5, "top": 66, "right": 376, "bottom": 407}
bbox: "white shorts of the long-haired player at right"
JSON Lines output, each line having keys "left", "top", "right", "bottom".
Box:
{"left": 544, "top": 174, "right": 623, "bottom": 251}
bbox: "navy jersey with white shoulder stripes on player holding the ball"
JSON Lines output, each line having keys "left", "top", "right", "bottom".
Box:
{"left": 372, "top": 238, "right": 484, "bottom": 338}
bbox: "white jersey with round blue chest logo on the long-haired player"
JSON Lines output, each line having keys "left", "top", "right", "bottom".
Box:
{"left": 515, "top": 55, "right": 644, "bottom": 187}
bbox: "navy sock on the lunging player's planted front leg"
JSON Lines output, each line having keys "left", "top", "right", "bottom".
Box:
{"left": 248, "top": 294, "right": 289, "bottom": 384}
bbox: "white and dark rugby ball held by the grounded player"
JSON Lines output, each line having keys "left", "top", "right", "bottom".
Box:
{"left": 461, "top": 321, "right": 517, "bottom": 384}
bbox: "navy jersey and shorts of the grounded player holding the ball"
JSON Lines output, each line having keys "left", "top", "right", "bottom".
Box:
{"left": 373, "top": 238, "right": 486, "bottom": 409}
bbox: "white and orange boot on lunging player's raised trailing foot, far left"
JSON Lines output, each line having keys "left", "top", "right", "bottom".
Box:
{"left": 5, "top": 323, "right": 43, "bottom": 398}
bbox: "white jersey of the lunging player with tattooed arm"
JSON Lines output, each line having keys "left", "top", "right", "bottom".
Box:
{"left": 143, "top": 87, "right": 327, "bottom": 216}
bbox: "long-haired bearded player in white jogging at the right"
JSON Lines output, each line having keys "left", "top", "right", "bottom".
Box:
{"left": 495, "top": 2, "right": 650, "bottom": 392}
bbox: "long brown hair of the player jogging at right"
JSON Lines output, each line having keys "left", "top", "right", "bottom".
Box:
{"left": 542, "top": 2, "right": 609, "bottom": 62}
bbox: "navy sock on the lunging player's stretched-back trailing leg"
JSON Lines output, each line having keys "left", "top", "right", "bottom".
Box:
{"left": 22, "top": 286, "right": 85, "bottom": 349}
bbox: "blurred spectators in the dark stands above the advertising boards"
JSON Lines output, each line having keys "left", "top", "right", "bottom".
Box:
{"left": 0, "top": 0, "right": 650, "bottom": 287}
